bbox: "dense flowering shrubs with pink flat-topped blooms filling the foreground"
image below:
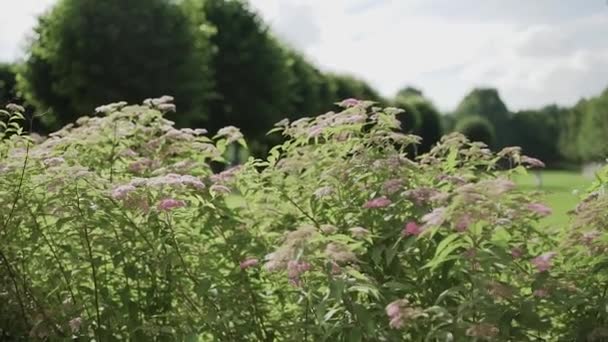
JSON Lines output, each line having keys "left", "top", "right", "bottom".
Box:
{"left": 0, "top": 97, "right": 608, "bottom": 341}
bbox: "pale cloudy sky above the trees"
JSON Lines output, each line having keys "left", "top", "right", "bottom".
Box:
{"left": 0, "top": 0, "right": 608, "bottom": 110}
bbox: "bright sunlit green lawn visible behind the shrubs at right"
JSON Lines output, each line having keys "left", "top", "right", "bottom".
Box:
{"left": 515, "top": 171, "right": 593, "bottom": 225}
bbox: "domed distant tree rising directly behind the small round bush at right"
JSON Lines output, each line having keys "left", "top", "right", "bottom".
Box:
{"left": 455, "top": 88, "right": 513, "bottom": 148}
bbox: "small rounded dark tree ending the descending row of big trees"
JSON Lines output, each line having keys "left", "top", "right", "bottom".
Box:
{"left": 393, "top": 87, "right": 442, "bottom": 153}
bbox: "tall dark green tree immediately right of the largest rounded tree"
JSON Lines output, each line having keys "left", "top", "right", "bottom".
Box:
{"left": 203, "top": 0, "right": 291, "bottom": 149}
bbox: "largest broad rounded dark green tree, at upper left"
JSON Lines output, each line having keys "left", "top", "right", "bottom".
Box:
{"left": 19, "top": 0, "right": 212, "bottom": 127}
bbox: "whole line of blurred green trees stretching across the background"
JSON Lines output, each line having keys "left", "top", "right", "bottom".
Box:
{"left": 0, "top": 0, "right": 608, "bottom": 166}
